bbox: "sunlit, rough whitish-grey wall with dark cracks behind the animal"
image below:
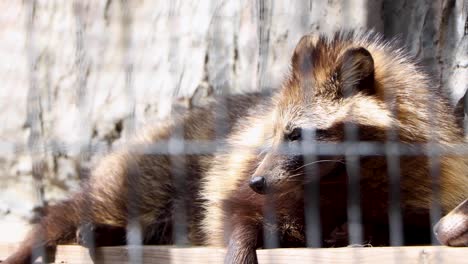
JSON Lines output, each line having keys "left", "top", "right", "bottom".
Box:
{"left": 0, "top": 0, "right": 468, "bottom": 240}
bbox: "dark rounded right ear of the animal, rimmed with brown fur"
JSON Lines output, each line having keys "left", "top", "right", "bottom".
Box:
{"left": 338, "top": 47, "right": 375, "bottom": 97}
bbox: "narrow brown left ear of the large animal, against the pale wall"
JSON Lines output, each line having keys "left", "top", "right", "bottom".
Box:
{"left": 291, "top": 35, "right": 318, "bottom": 79}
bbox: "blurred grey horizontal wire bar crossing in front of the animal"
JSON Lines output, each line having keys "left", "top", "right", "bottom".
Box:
{"left": 0, "top": 139, "right": 468, "bottom": 156}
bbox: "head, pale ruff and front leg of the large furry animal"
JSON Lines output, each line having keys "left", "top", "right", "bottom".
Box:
{"left": 201, "top": 33, "right": 468, "bottom": 263}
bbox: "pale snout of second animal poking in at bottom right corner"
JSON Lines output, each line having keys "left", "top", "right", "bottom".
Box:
{"left": 434, "top": 199, "right": 468, "bottom": 247}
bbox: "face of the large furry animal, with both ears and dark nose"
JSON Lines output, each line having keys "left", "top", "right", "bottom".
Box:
{"left": 250, "top": 33, "right": 392, "bottom": 194}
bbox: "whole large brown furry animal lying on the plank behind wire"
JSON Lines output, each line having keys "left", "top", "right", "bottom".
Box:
{"left": 6, "top": 33, "right": 468, "bottom": 263}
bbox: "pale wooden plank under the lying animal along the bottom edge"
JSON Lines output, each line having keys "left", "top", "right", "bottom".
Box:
{"left": 0, "top": 244, "right": 468, "bottom": 264}
